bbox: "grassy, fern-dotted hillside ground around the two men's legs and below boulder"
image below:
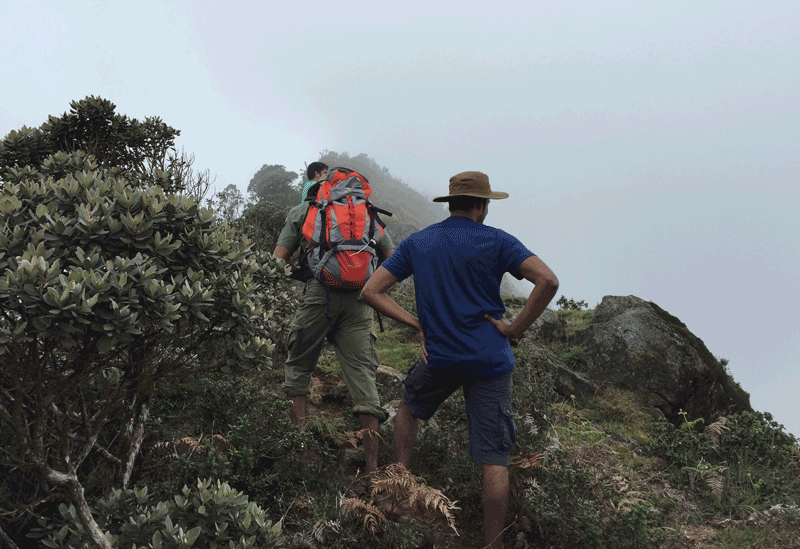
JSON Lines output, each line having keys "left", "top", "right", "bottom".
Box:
{"left": 18, "top": 284, "right": 800, "bottom": 549}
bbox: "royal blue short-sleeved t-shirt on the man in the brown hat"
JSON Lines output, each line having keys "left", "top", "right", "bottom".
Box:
{"left": 383, "top": 216, "right": 534, "bottom": 378}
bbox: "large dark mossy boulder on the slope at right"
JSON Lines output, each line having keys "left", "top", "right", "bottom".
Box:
{"left": 569, "top": 296, "right": 752, "bottom": 424}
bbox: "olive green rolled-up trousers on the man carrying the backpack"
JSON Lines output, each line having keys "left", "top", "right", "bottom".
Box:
{"left": 282, "top": 279, "right": 389, "bottom": 422}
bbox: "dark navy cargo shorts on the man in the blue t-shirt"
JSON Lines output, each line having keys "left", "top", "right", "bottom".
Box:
{"left": 403, "top": 360, "right": 517, "bottom": 466}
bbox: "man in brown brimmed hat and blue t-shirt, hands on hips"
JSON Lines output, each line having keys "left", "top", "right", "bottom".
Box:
{"left": 361, "top": 172, "right": 558, "bottom": 548}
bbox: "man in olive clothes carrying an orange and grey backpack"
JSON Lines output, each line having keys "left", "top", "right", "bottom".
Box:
{"left": 274, "top": 162, "right": 394, "bottom": 473}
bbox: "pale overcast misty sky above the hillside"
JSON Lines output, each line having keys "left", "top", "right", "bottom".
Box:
{"left": 0, "top": 0, "right": 800, "bottom": 435}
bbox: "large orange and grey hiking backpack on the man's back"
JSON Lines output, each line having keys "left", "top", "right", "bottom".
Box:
{"left": 303, "top": 167, "right": 392, "bottom": 290}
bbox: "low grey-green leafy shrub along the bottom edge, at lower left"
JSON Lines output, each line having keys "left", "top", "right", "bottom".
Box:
{"left": 38, "top": 480, "right": 286, "bottom": 549}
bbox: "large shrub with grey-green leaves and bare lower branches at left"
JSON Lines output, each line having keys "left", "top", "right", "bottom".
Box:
{"left": 0, "top": 151, "right": 293, "bottom": 532}
